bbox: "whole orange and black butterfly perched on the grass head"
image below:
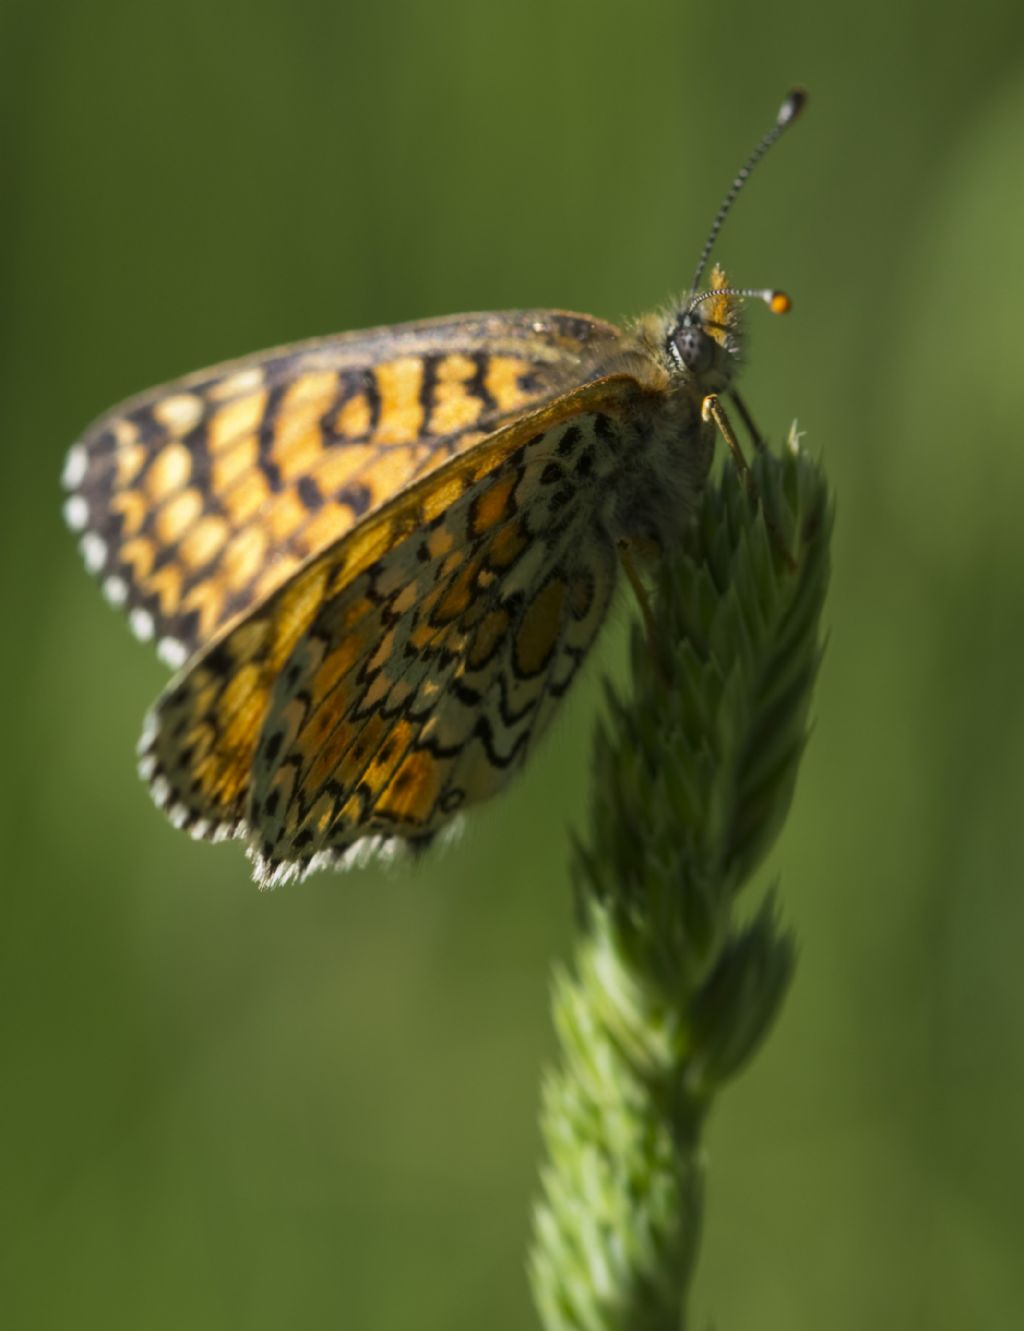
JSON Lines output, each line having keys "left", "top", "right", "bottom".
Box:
{"left": 64, "top": 92, "right": 803, "bottom": 886}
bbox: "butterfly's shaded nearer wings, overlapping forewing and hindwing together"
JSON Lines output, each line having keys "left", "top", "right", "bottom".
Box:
{"left": 141, "top": 373, "right": 638, "bottom": 884}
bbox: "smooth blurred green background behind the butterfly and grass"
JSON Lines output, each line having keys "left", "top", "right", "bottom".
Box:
{"left": 0, "top": 0, "right": 1024, "bottom": 1331}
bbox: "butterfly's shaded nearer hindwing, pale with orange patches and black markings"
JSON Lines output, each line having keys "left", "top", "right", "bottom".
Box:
{"left": 248, "top": 411, "right": 617, "bottom": 885}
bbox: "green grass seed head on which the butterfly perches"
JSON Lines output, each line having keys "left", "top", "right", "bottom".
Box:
{"left": 531, "top": 435, "right": 830, "bottom": 1331}
